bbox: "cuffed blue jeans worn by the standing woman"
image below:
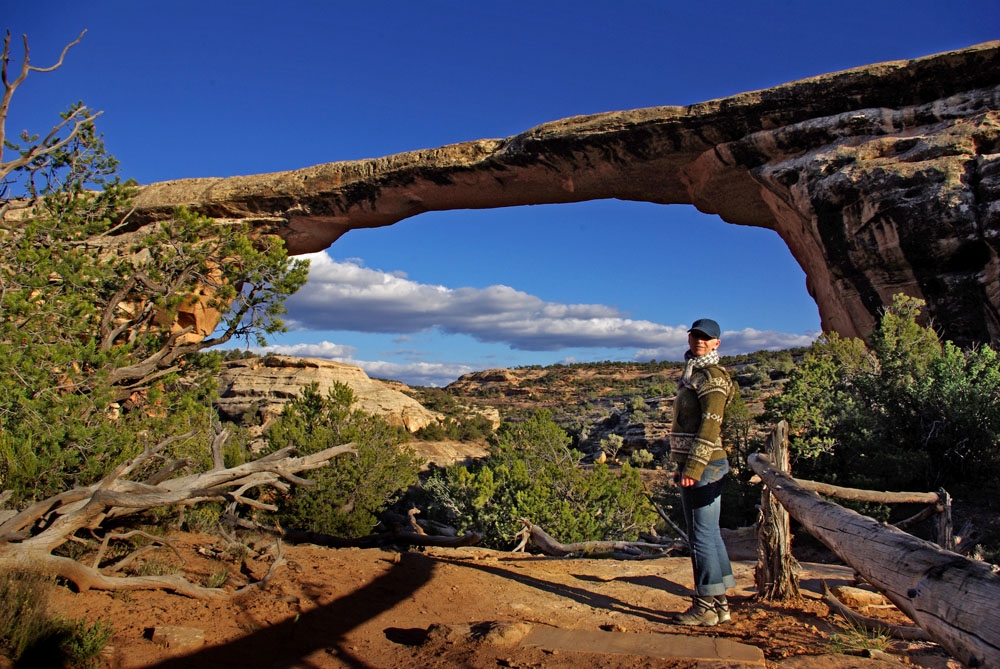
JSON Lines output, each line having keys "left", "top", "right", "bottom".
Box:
{"left": 681, "top": 460, "right": 736, "bottom": 597}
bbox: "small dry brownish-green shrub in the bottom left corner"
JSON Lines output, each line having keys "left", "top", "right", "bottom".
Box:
{"left": 0, "top": 569, "right": 112, "bottom": 667}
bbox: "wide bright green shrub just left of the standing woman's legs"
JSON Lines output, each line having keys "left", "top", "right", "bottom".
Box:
{"left": 423, "top": 410, "right": 655, "bottom": 548}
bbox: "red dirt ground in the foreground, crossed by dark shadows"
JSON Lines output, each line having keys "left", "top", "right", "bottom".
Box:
{"left": 17, "top": 534, "right": 960, "bottom": 669}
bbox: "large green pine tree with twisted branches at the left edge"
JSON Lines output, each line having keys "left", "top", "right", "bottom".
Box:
{"left": 0, "top": 94, "right": 308, "bottom": 506}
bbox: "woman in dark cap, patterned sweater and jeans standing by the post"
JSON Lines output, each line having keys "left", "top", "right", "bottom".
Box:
{"left": 670, "top": 318, "right": 736, "bottom": 627}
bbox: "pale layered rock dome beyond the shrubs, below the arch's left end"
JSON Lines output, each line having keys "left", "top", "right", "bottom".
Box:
{"left": 216, "top": 355, "right": 443, "bottom": 432}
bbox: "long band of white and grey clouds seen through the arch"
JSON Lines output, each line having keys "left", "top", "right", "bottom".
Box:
{"left": 266, "top": 253, "right": 818, "bottom": 386}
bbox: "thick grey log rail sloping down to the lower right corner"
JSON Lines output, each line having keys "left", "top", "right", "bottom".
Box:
{"left": 747, "top": 453, "right": 1000, "bottom": 667}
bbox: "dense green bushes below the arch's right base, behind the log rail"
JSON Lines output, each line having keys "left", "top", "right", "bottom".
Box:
{"left": 767, "top": 295, "right": 1000, "bottom": 490}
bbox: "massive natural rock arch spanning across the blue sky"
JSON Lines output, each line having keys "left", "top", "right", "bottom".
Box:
{"left": 133, "top": 42, "right": 1000, "bottom": 344}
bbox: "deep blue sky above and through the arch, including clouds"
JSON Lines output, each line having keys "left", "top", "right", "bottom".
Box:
{"left": 4, "top": 0, "right": 1000, "bottom": 386}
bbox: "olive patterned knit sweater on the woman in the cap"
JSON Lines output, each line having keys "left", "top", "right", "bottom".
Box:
{"left": 670, "top": 351, "right": 736, "bottom": 481}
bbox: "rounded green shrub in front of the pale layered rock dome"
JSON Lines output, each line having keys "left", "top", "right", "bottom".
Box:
{"left": 265, "top": 383, "right": 421, "bottom": 537}
